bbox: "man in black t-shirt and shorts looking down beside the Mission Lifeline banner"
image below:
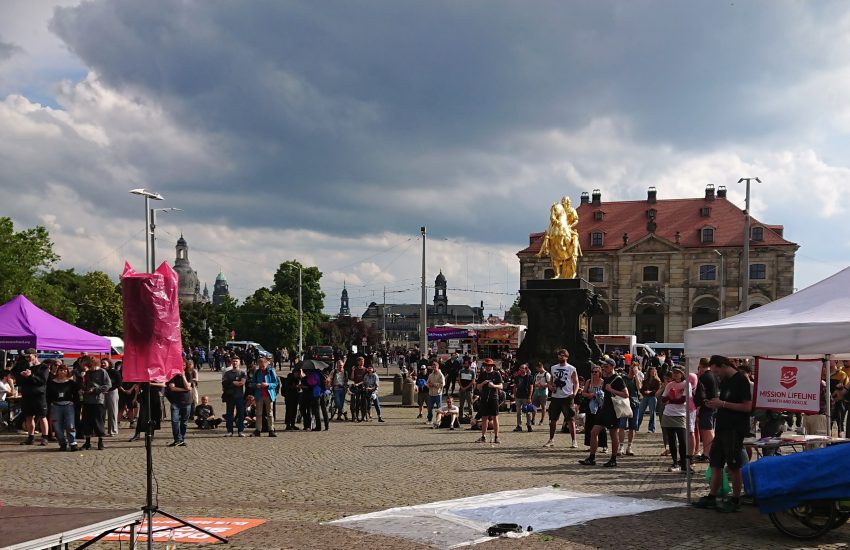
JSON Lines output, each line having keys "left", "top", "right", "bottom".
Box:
{"left": 694, "top": 355, "right": 752, "bottom": 512}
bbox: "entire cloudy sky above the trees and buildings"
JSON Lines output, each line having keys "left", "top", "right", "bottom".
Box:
{"left": 0, "top": 0, "right": 850, "bottom": 315}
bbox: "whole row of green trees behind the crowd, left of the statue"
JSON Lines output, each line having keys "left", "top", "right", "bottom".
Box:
{"left": 0, "top": 217, "right": 379, "bottom": 356}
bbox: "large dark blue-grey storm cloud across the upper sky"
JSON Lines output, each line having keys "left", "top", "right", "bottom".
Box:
{"left": 52, "top": 0, "right": 841, "bottom": 242}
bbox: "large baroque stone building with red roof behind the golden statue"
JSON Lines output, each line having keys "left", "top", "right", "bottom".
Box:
{"left": 517, "top": 185, "right": 799, "bottom": 342}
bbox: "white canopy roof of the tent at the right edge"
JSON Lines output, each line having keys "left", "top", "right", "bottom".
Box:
{"left": 685, "top": 267, "right": 850, "bottom": 357}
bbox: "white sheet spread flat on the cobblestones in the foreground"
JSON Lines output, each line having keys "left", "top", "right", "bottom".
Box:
{"left": 328, "top": 487, "right": 681, "bottom": 548}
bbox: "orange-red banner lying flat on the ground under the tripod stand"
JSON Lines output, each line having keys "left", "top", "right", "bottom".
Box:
{"left": 84, "top": 516, "right": 266, "bottom": 544}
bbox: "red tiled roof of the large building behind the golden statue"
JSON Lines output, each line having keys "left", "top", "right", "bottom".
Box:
{"left": 517, "top": 198, "right": 797, "bottom": 256}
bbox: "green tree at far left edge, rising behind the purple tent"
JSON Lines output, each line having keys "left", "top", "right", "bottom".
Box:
{"left": 0, "top": 217, "right": 59, "bottom": 303}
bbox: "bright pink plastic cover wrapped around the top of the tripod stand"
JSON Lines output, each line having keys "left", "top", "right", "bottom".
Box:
{"left": 121, "top": 262, "right": 183, "bottom": 382}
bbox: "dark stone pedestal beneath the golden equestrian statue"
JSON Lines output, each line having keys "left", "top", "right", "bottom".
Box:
{"left": 517, "top": 279, "right": 596, "bottom": 378}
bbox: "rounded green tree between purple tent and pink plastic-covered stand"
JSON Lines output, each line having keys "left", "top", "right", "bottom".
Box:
{"left": 73, "top": 271, "right": 124, "bottom": 336}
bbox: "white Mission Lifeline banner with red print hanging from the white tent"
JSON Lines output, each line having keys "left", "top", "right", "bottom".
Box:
{"left": 753, "top": 357, "right": 823, "bottom": 414}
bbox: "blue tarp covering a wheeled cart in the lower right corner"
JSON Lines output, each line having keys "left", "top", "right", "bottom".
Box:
{"left": 743, "top": 443, "right": 850, "bottom": 513}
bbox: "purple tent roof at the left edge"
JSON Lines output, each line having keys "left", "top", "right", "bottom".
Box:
{"left": 0, "top": 294, "right": 110, "bottom": 353}
